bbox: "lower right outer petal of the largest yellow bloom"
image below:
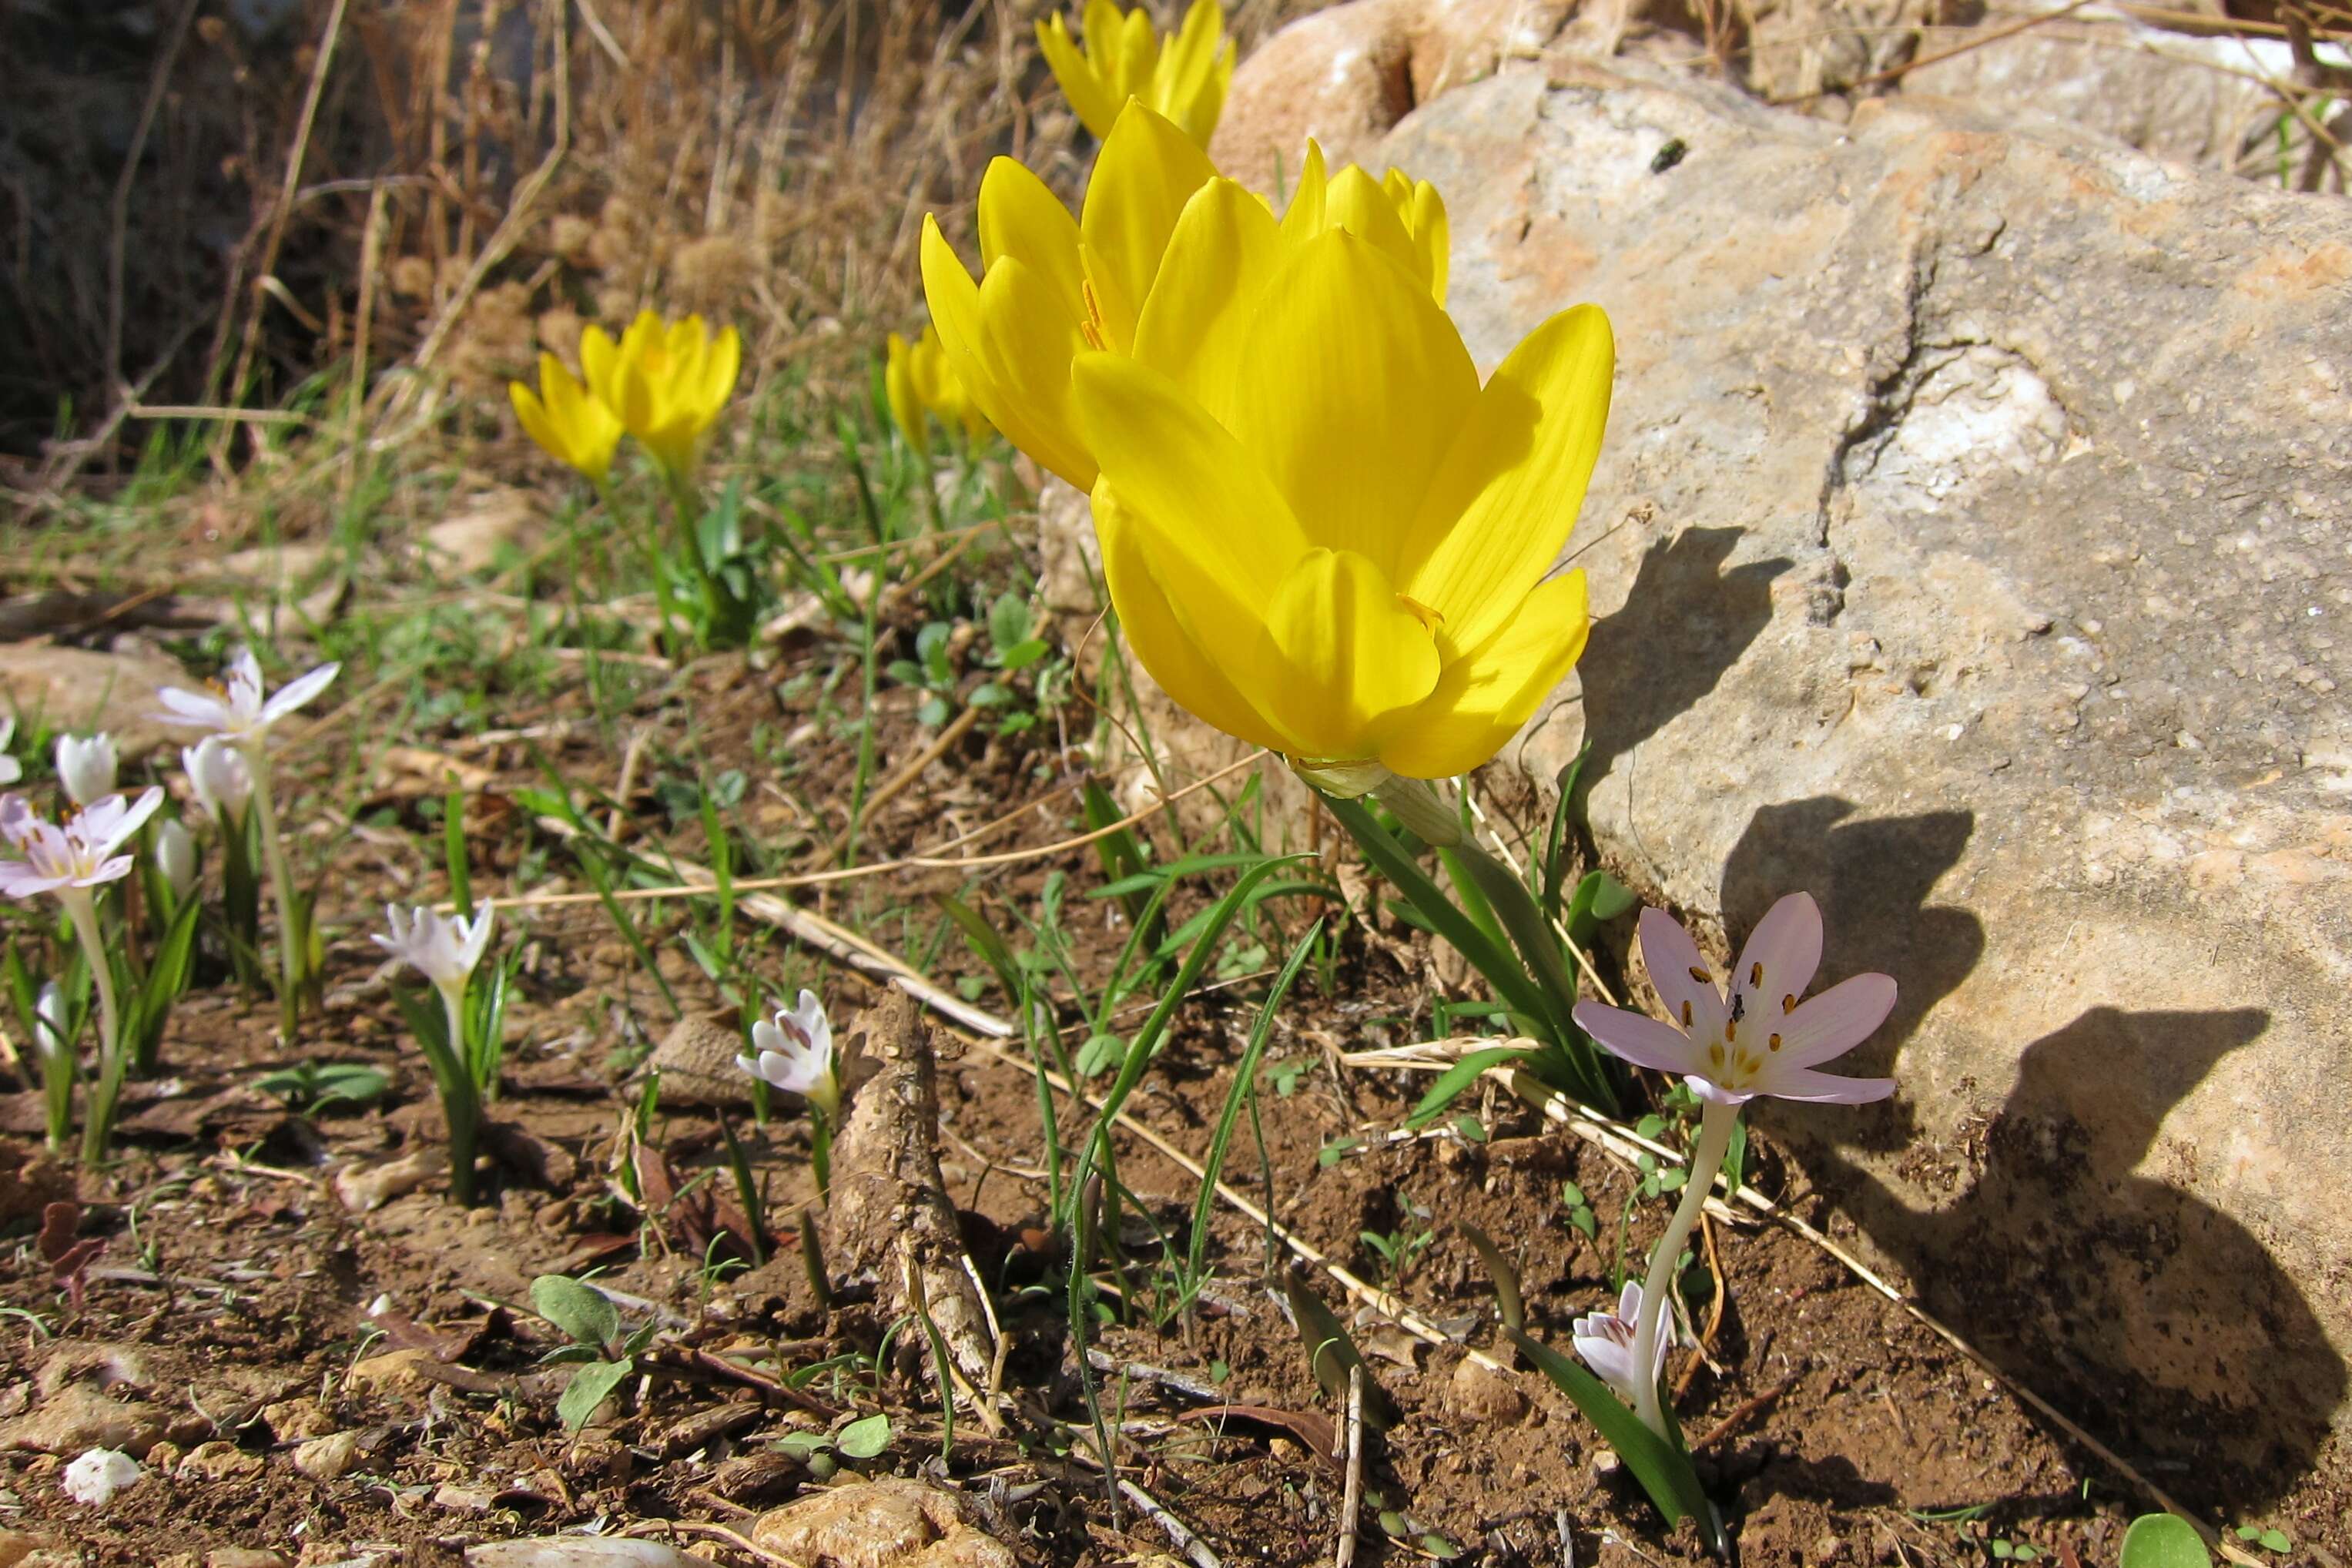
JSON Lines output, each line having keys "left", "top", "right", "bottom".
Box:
{"left": 1381, "top": 571, "right": 1593, "bottom": 778}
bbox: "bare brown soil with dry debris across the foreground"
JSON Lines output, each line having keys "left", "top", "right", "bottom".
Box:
{"left": 0, "top": 661, "right": 2352, "bottom": 1568}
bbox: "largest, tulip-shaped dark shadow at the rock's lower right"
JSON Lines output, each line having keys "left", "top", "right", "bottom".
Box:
{"left": 1814, "top": 1006, "right": 2345, "bottom": 1512}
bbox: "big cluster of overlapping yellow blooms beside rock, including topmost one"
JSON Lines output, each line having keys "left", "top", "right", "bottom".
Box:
{"left": 922, "top": 0, "right": 1616, "bottom": 795}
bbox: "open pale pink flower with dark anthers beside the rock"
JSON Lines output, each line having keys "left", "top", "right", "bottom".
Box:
{"left": 1576, "top": 893, "right": 1896, "bottom": 1105}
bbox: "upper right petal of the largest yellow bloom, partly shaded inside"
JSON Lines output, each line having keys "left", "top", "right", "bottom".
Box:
{"left": 1397, "top": 306, "right": 1616, "bottom": 646}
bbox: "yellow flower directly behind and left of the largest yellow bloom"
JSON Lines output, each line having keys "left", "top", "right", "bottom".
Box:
{"left": 922, "top": 101, "right": 1216, "bottom": 489}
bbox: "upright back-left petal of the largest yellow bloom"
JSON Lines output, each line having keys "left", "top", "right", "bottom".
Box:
{"left": 1134, "top": 179, "right": 1282, "bottom": 416}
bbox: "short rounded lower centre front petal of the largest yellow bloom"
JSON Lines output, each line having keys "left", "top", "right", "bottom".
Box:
{"left": 1258, "top": 550, "right": 1439, "bottom": 762}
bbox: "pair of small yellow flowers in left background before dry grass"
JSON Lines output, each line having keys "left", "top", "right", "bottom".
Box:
{"left": 506, "top": 310, "right": 743, "bottom": 484}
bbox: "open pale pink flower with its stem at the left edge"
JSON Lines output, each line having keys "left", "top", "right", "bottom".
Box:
{"left": 0, "top": 786, "right": 162, "bottom": 1161}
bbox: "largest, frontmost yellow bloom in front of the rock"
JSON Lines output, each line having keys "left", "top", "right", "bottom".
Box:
{"left": 1073, "top": 179, "right": 1616, "bottom": 792}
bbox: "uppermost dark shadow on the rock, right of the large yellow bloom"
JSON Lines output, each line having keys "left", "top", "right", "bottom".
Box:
{"left": 1576, "top": 529, "right": 1790, "bottom": 788}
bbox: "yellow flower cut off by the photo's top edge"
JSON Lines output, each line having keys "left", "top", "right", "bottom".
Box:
{"left": 1037, "top": 0, "right": 1235, "bottom": 148}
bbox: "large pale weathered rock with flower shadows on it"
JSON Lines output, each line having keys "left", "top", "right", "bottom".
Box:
{"left": 1049, "top": 30, "right": 2352, "bottom": 1488}
